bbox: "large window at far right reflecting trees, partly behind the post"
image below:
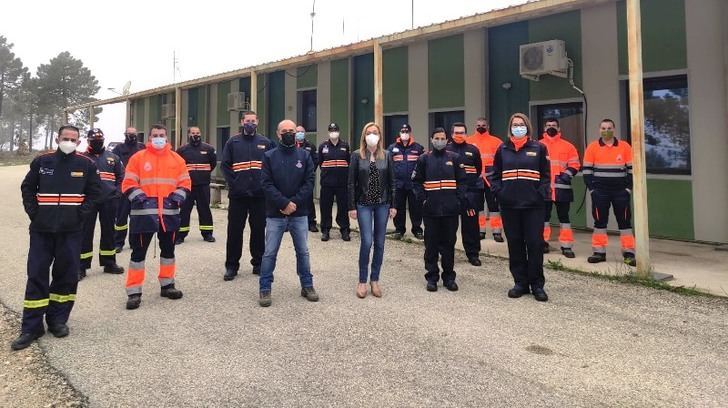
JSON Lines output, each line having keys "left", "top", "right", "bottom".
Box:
{"left": 623, "top": 75, "right": 691, "bottom": 174}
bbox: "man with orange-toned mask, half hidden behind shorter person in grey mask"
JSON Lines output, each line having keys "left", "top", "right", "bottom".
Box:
{"left": 447, "top": 122, "right": 485, "bottom": 266}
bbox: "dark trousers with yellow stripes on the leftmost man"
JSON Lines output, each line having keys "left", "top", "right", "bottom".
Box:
{"left": 21, "top": 231, "right": 83, "bottom": 333}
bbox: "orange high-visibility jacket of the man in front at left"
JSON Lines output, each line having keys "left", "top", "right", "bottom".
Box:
{"left": 121, "top": 143, "right": 192, "bottom": 231}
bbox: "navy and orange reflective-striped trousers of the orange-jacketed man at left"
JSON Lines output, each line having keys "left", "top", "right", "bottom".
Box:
{"left": 126, "top": 231, "right": 175, "bottom": 295}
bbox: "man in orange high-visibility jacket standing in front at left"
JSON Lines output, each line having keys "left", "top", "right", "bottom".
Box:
{"left": 121, "top": 125, "right": 192, "bottom": 310}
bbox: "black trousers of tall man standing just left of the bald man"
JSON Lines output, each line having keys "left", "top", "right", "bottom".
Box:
{"left": 225, "top": 197, "right": 265, "bottom": 271}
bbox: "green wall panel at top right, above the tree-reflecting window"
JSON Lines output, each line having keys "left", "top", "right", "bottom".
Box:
{"left": 617, "top": 0, "right": 688, "bottom": 75}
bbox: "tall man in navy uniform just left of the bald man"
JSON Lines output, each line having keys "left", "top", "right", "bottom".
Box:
{"left": 220, "top": 111, "right": 273, "bottom": 281}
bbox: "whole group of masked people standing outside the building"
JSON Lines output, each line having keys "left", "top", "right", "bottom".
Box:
{"left": 12, "top": 111, "right": 635, "bottom": 350}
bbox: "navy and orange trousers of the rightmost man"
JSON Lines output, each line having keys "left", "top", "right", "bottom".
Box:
{"left": 591, "top": 189, "right": 634, "bottom": 256}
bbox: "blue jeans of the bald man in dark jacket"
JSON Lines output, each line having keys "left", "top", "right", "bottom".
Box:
{"left": 260, "top": 216, "right": 313, "bottom": 292}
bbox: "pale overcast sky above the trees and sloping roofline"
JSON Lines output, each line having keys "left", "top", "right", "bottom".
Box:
{"left": 0, "top": 0, "right": 526, "bottom": 140}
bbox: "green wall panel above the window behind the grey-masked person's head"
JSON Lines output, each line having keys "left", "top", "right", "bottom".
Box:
{"left": 427, "top": 34, "right": 465, "bottom": 109}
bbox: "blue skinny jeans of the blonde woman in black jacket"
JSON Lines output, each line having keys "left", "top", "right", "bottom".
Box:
{"left": 356, "top": 204, "right": 389, "bottom": 283}
